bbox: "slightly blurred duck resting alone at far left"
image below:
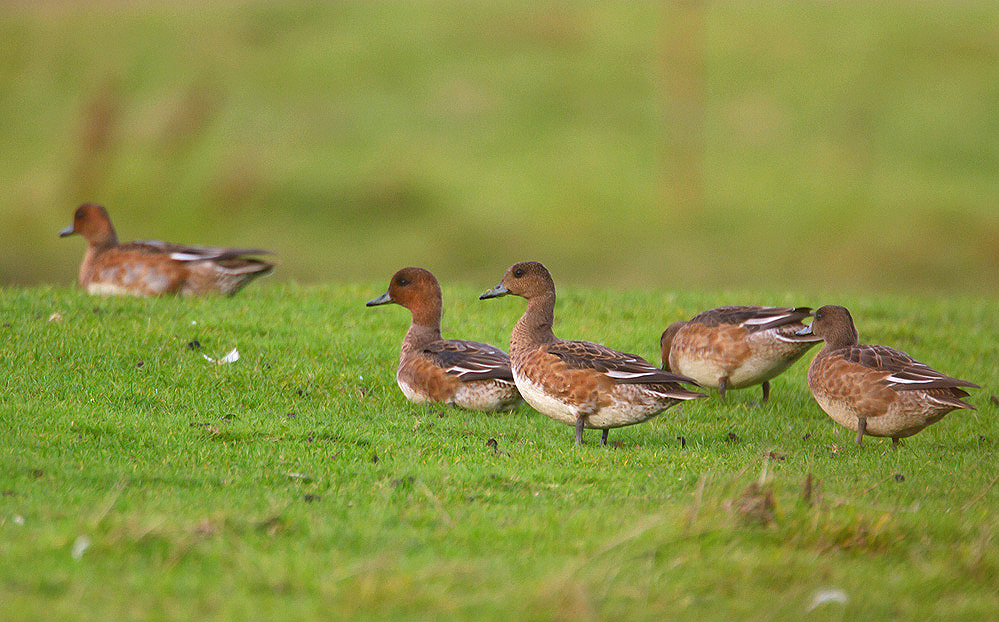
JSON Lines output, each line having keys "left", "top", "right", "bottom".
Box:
{"left": 59, "top": 203, "right": 274, "bottom": 296}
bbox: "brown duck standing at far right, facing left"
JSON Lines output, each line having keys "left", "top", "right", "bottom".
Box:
{"left": 798, "top": 305, "right": 981, "bottom": 449}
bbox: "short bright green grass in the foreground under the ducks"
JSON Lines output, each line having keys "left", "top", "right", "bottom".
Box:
{"left": 0, "top": 286, "right": 999, "bottom": 620}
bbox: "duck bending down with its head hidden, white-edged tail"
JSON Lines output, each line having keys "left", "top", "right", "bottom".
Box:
{"left": 659, "top": 305, "right": 821, "bottom": 404}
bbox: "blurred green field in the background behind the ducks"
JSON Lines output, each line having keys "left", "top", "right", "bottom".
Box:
{"left": 0, "top": 0, "right": 999, "bottom": 293}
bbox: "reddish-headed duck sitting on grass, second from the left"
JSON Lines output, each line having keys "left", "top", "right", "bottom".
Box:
{"left": 365, "top": 267, "right": 521, "bottom": 412}
